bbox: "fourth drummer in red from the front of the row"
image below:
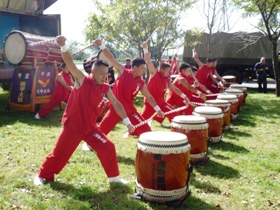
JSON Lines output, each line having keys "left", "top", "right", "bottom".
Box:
{"left": 166, "top": 61, "right": 205, "bottom": 112}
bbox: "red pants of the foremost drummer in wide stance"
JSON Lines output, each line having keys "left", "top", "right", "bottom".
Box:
{"left": 38, "top": 119, "right": 119, "bottom": 181}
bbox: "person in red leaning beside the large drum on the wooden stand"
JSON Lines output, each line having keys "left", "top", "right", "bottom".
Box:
{"left": 35, "top": 63, "right": 74, "bottom": 120}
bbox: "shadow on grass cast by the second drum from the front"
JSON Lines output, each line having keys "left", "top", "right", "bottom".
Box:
{"left": 194, "top": 157, "right": 240, "bottom": 179}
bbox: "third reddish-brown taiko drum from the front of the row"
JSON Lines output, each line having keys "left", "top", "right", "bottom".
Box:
{"left": 193, "top": 106, "right": 224, "bottom": 143}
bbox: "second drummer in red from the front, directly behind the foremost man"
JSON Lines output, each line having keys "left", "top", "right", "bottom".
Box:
{"left": 95, "top": 40, "right": 164, "bottom": 137}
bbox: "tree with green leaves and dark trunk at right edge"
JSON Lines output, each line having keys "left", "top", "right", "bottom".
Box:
{"left": 234, "top": 0, "right": 280, "bottom": 97}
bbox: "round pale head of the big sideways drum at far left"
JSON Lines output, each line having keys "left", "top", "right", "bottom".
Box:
{"left": 4, "top": 32, "right": 27, "bottom": 64}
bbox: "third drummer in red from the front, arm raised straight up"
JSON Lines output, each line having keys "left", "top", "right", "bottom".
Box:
{"left": 141, "top": 42, "right": 189, "bottom": 123}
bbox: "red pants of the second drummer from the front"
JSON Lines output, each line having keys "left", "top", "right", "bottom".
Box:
{"left": 99, "top": 106, "right": 151, "bottom": 137}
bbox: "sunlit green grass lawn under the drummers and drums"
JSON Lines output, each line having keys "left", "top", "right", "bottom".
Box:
{"left": 0, "top": 90, "right": 280, "bottom": 210}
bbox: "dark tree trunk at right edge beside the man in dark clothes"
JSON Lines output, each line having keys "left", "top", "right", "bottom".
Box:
{"left": 271, "top": 39, "right": 280, "bottom": 97}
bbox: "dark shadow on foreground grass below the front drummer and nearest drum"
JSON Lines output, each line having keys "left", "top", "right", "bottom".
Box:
{"left": 50, "top": 182, "right": 216, "bottom": 210}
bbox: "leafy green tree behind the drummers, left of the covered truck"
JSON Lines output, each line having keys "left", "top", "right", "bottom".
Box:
{"left": 85, "top": 0, "right": 195, "bottom": 66}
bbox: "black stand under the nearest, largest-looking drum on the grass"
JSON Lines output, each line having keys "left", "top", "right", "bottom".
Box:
{"left": 131, "top": 164, "right": 193, "bottom": 207}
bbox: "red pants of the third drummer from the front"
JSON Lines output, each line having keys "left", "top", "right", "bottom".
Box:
{"left": 141, "top": 102, "right": 178, "bottom": 123}
